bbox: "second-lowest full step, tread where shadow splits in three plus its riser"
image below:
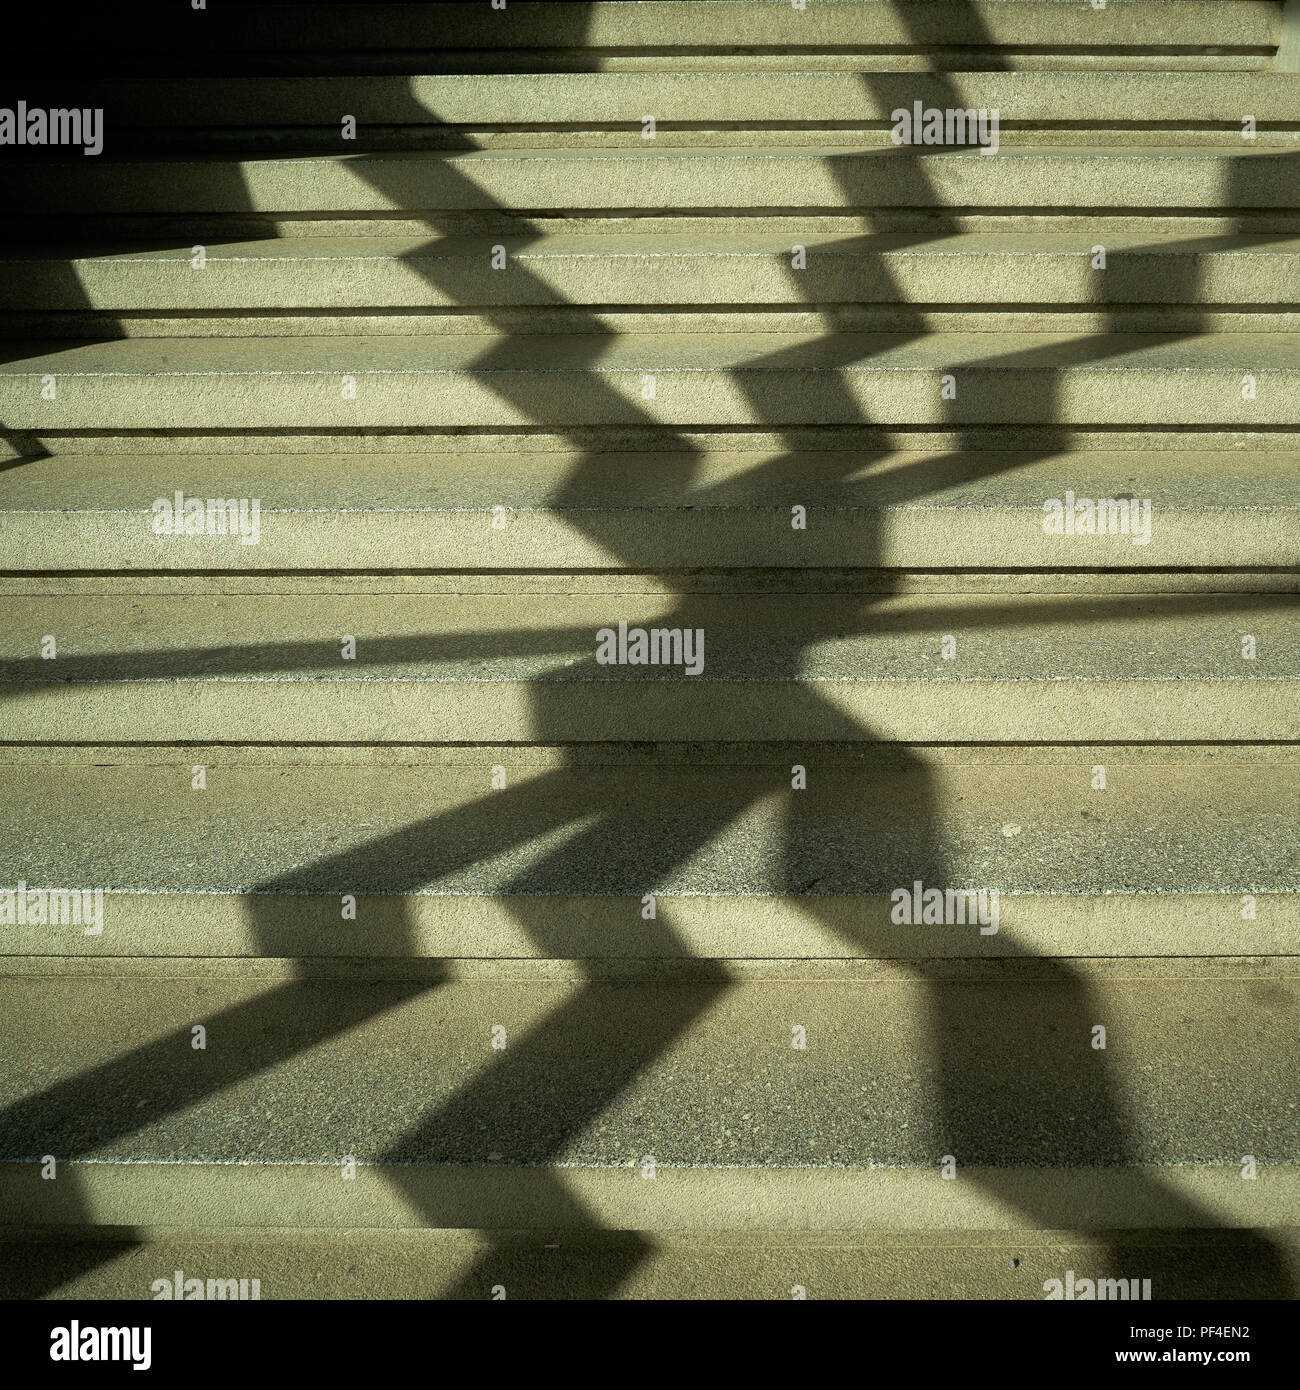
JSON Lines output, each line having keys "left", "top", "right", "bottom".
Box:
{"left": 0, "top": 744, "right": 1300, "bottom": 961}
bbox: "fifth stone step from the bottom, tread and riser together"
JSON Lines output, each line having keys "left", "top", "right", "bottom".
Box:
{"left": 0, "top": 332, "right": 1300, "bottom": 432}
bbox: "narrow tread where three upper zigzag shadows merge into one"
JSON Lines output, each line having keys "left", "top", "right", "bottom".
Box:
{"left": 0, "top": 449, "right": 1300, "bottom": 508}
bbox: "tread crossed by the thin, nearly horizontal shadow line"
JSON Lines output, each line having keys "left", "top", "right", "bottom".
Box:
{"left": 0, "top": 586, "right": 1300, "bottom": 678}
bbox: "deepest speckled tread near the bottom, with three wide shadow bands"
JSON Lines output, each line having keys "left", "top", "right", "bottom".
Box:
{"left": 0, "top": 973, "right": 1300, "bottom": 1167}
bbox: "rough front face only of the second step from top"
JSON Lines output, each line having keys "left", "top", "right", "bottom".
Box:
{"left": 55, "top": 72, "right": 1296, "bottom": 132}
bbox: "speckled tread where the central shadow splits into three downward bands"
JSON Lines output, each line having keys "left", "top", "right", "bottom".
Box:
{"left": 0, "top": 748, "right": 1300, "bottom": 895}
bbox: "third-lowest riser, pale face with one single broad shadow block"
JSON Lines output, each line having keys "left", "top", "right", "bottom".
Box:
{"left": 10, "top": 680, "right": 1300, "bottom": 744}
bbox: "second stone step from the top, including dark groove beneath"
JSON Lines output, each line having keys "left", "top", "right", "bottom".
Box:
{"left": 38, "top": 71, "right": 1300, "bottom": 154}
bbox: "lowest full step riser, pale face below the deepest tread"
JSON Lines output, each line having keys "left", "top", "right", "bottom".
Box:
{"left": 10, "top": 1150, "right": 1297, "bottom": 1239}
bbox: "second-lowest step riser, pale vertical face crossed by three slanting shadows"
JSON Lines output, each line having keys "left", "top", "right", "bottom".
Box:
{"left": 0, "top": 895, "right": 1300, "bottom": 961}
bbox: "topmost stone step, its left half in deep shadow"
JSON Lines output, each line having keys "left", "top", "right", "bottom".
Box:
{"left": 35, "top": 0, "right": 1282, "bottom": 74}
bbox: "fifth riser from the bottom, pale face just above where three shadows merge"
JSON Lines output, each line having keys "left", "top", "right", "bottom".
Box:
{"left": 0, "top": 383, "right": 1284, "bottom": 431}
